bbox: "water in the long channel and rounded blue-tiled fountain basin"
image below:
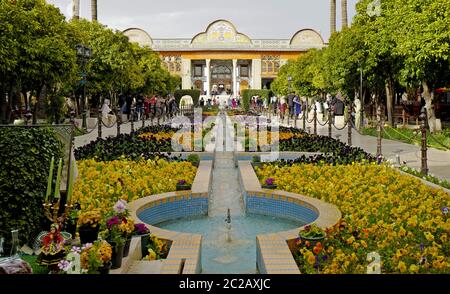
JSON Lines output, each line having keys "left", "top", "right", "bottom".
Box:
{"left": 157, "top": 115, "right": 304, "bottom": 274}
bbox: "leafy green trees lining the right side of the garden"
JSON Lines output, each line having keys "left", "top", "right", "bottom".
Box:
{"left": 272, "top": 0, "right": 450, "bottom": 128}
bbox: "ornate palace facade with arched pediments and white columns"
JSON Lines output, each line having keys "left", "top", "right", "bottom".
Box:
{"left": 124, "top": 20, "right": 325, "bottom": 95}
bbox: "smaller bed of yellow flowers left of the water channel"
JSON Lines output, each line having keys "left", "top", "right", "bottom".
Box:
{"left": 73, "top": 159, "right": 197, "bottom": 213}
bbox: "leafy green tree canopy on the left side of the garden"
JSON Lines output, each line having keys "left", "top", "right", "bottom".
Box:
{"left": 0, "top": 0, "right": 179, "bottom": 122}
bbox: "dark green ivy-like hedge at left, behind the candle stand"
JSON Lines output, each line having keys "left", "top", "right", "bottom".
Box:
{"left": 0, "top": 127, "right": 63, "bottom": 254}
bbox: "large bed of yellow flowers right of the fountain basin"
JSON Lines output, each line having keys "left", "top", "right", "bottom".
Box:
{"left": 257, "top": 163, "right": 450, "bottom": 273}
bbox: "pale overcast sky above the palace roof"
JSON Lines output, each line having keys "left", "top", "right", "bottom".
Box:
{"left": 47, "top": 0, "right": 358, "bottom": 40}
